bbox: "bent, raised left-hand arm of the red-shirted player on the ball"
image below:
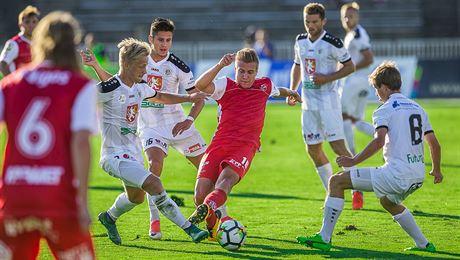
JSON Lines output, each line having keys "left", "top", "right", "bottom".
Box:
{"left": 195, "top": 53, "right": 236, "bottom": 94}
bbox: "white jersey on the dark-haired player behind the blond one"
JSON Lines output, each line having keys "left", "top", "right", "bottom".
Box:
{"left": 139, "top": 53, "right": 195, "bottom": 131}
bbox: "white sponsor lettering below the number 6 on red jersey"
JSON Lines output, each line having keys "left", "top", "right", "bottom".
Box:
{"left": 5, "top": 165, "right": 64, "bottom": 186}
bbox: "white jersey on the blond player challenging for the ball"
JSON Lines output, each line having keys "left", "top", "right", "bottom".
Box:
{"left": 98, "top": 75, "right": 157, "bottom": 162}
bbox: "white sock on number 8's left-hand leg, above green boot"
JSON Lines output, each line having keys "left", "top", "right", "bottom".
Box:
{"left": 319, "top": 196, "right": 344, "bottom": 243}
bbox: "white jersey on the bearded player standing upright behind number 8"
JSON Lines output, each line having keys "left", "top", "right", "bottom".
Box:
{"left": 294, "top": 31, "right": 351, "bottom": 110}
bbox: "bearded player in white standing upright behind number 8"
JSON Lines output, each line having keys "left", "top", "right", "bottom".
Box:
{"left": 287, "top": 3, "right": 354, "bottom": 204}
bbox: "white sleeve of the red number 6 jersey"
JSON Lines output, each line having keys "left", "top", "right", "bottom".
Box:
{"left": 70, "top": 81, "right": 97, "bottom": 133}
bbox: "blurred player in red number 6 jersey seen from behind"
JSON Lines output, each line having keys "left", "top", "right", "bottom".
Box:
{"left": 0, "top": 12, "right": 96, "bottom": 259}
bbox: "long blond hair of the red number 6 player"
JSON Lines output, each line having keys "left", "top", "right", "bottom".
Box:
{"left": 32, "top": 11, "right": 81, "bottom": 70}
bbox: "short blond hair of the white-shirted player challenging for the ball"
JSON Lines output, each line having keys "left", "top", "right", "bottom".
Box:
{"left": 117, "top": 38, "right": 150, "bottom": 66}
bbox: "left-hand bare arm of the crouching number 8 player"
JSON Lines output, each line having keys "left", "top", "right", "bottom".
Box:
{"left": 336, "top": 126, "right": 388, "bottom": 167}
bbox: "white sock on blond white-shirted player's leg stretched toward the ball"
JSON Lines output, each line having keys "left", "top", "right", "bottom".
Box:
{"left": 149, "top": 191, "right": 191, "bottom": 229}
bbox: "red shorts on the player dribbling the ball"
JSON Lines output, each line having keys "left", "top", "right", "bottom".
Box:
{"left": 197, "top": 143, "right": 256, "bottom": 183}
